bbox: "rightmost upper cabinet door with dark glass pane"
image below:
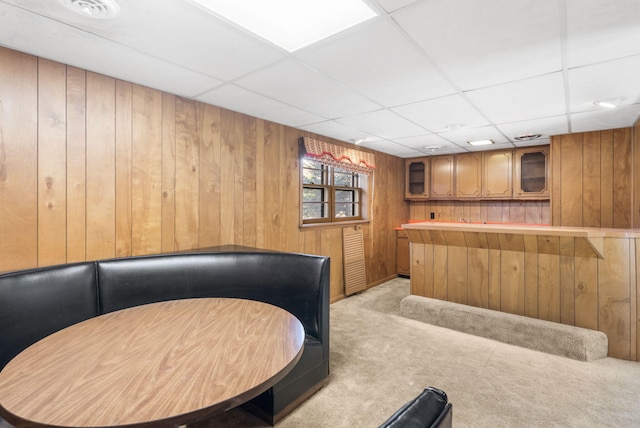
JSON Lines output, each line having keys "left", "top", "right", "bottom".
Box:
{"left": 513, "top": 146, "right": 551, "bottom": 199}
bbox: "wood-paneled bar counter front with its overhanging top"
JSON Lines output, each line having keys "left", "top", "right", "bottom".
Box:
{"left": 403, "top": 222, "right": 640, "bottom": 361}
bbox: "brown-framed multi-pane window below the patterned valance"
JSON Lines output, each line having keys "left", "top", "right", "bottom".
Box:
{"left": 302, "top": 158, "right": 367, "bottom": 224}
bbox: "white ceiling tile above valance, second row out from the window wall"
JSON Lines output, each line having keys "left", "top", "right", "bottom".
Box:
{"left": 336, "top": 110, "right": 427, "bottom": 140}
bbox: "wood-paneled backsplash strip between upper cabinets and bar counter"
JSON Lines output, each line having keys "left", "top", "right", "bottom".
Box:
{"left": 409, "top": 200, "right": 551, "bottom": 224}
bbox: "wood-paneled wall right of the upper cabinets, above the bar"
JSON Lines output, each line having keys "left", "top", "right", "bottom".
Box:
{"left": 551, "top": 126, "right": 640, "bottom": 229}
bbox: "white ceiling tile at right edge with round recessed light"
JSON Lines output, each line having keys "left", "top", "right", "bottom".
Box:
{"left": 569, "top": 54, "right": 640, "bottom": 112}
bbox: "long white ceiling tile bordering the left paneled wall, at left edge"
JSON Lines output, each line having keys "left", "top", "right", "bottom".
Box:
{"left": 0, "top": 2, "right": 222, "bottom": 97}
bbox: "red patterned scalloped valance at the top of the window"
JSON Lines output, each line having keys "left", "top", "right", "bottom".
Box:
{"left": 300, "top": 137, "right": 376, "bottom": 174}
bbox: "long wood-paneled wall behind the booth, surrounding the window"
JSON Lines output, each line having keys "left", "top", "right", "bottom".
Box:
{"left": 0, "top": 48, "right": 409, "bottom": 301}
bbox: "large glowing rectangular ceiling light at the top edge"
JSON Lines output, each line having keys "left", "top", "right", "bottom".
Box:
{"left": 191, "top": 0, "right": 376, "bottom": 52}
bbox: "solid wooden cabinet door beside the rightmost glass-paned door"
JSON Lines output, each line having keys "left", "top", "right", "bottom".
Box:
{"left": 482, "top": 150, "right": 513, "bottom": 199}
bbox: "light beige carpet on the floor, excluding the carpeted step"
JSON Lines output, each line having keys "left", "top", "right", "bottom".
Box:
{"left": 193, "top": 278, "right": 640, "bottom": 428}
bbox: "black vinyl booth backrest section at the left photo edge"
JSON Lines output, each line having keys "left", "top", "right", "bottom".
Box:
{"left": 0, "top": 262, "right": 99, "bottom": 369}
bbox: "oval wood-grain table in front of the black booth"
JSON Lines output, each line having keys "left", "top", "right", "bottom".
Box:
{"left": 0, "top": 298, "right": 304, "bottom": 427}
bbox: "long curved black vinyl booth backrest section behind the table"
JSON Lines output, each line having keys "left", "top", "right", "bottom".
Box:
{"left": 97, "top": 251, "right": 329, "bottom": 346}
